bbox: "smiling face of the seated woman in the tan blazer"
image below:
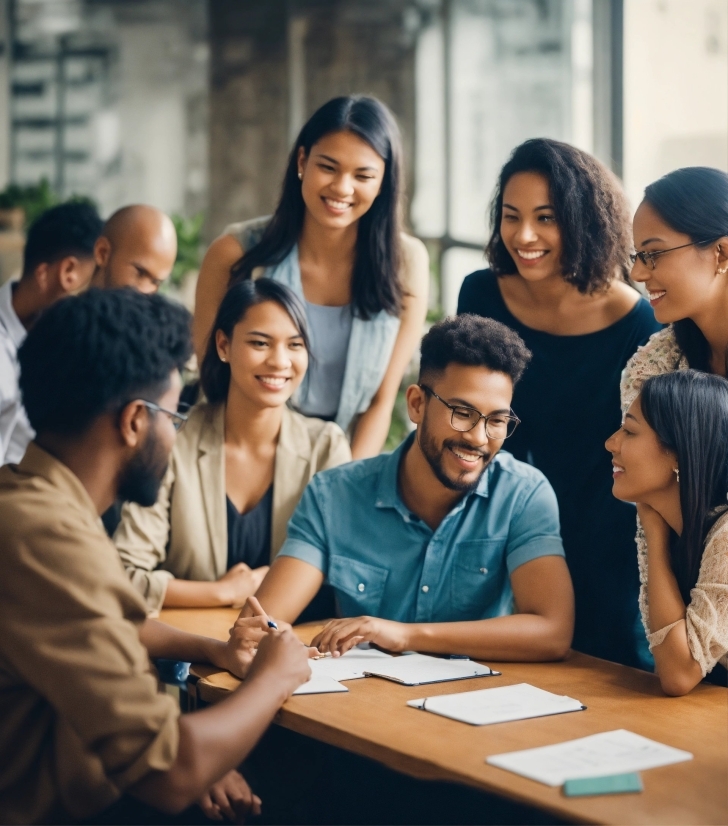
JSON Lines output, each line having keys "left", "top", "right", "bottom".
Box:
{"left": 215, "top": 301, "right": 308, "bottom": 407}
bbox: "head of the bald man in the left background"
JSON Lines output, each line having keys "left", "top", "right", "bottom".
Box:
{"left": 92, "top": 204, "right": 177, "bottom": 293}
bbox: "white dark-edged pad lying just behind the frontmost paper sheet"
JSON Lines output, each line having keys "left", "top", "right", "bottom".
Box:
{"left": 407, "top": 683, "right": 585, "bottom": 726}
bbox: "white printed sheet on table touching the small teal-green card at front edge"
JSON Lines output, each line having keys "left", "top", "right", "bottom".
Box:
{"left": 485, "top": 729, "right": 693, "bottom": 786}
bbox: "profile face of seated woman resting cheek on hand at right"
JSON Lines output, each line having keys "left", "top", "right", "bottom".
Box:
{"left": 605, "top": 396, "right": 679, "bottom": 506}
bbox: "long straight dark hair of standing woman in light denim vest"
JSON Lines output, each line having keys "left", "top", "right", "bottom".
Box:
{"left": 231, "top": 95, "right": 404, "bottom": 319}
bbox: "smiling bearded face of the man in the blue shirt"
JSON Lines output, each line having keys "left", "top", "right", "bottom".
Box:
{"left": 407, "top": 363, "right": 513, "bottom": 492}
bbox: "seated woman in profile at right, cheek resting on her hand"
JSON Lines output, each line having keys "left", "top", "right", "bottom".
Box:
{"left": 606, "top": 369, "right": 728, "bottom": 695}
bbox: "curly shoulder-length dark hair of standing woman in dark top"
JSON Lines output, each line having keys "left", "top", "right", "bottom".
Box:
{"left": 485, "top": 138, "right": 632, "bottom": 294}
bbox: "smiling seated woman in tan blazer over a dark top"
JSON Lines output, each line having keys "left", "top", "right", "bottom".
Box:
{"left": 114, "top": 278, "right": 351, "bottom": 613}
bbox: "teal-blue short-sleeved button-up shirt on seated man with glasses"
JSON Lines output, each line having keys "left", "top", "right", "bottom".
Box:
{"left": 279, "top": 434, "right": 564, "bottom": 622}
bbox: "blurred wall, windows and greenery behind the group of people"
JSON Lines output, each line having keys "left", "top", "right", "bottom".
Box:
{"left": 0, "top": 0, "right": 728, "bottom": 316}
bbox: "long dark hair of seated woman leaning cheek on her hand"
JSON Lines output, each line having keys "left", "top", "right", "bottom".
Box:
{"left": 640, "top": 370, "right": 728, "bottom": 604}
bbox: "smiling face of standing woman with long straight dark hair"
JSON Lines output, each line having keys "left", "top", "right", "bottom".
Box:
{"left": 298, "top": 132, "right": 385, "bottom": 229}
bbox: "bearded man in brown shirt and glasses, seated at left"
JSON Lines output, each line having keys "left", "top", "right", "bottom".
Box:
{"left": 0, "top": 290, "right": 310, "bottom": 823}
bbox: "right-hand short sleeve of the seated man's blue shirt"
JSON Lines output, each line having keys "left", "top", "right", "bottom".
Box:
{"left": 506, "top": 478, "right": 564, "bottom": 574}
